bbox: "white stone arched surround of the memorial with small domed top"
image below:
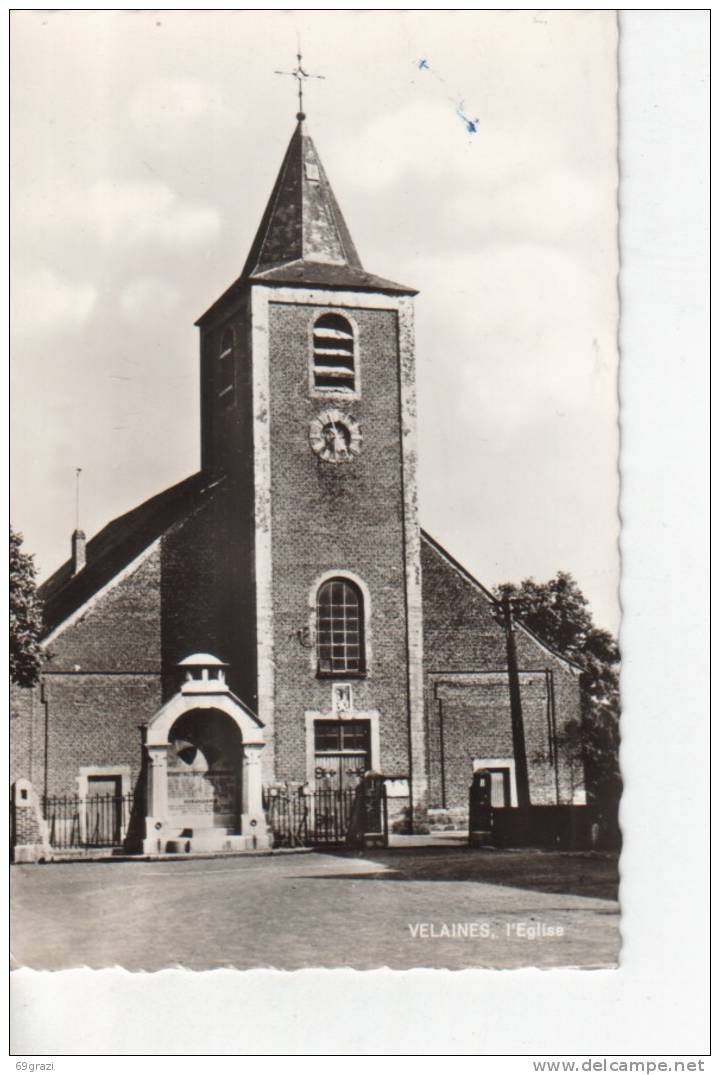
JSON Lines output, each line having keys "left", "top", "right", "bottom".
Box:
{"left": 143, "top": 654, "right": 270, "bottom": 855}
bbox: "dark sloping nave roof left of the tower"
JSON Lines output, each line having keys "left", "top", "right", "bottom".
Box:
{"left": 38, "top": 473, "right": 217, "bottom": 634}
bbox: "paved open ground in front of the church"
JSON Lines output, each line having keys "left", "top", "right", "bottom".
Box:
{"left": 11, "top": 844, "right": 619, "bottom": 971}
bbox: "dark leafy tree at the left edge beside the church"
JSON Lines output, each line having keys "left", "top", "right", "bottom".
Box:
{"left": 10, "top": 526, "right": 42, "bottom": 687}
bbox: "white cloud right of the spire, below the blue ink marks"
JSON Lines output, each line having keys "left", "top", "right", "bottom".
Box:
{"left": 323, "top": 99, "right": 617, "bottom": 262}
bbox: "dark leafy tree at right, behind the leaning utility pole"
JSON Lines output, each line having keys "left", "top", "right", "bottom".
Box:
{"left": 495, "top": 571, "right": 622, "bottom": 829}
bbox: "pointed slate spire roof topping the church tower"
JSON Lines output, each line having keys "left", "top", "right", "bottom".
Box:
{"left": 197, "top": 120, "right": 417, "bottom": 325}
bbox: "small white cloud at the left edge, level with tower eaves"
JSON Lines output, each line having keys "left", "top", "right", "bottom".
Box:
{"left": 12, "top": 267, "right": 98, "bottom": 335}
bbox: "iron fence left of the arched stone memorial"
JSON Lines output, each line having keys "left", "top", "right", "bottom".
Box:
{"left": 42, "top": 794, "right": 133, "bottom": 850}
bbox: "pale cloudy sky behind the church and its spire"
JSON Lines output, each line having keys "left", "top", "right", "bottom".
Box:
{"left": 11, "top": 10, "right": 619, "bottom": 631}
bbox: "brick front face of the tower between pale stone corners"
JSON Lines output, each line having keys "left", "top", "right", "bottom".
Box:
{"left": 269, "top": 302, "right": 408, "bottom": 779}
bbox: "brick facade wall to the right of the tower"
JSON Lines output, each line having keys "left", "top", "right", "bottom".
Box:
{"left": 422, "top": 540, "right": 579, "bottom": 807}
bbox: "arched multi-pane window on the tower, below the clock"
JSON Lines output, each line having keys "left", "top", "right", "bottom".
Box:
{"left": 317, "top": 578, "right": 365, "bottom": 675}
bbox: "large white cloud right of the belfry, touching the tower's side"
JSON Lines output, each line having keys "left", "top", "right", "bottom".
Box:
{"left": 416, "top": 244, "right": 617, "bottom": 428}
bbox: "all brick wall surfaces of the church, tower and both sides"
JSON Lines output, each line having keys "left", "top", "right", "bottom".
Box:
{"left": 11, "top": 290, "right": 579, "bottom": 807}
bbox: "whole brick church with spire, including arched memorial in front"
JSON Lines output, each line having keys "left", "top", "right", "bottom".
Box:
{"left": 11, "top": 102, "right": 584, "bottom": 854}
